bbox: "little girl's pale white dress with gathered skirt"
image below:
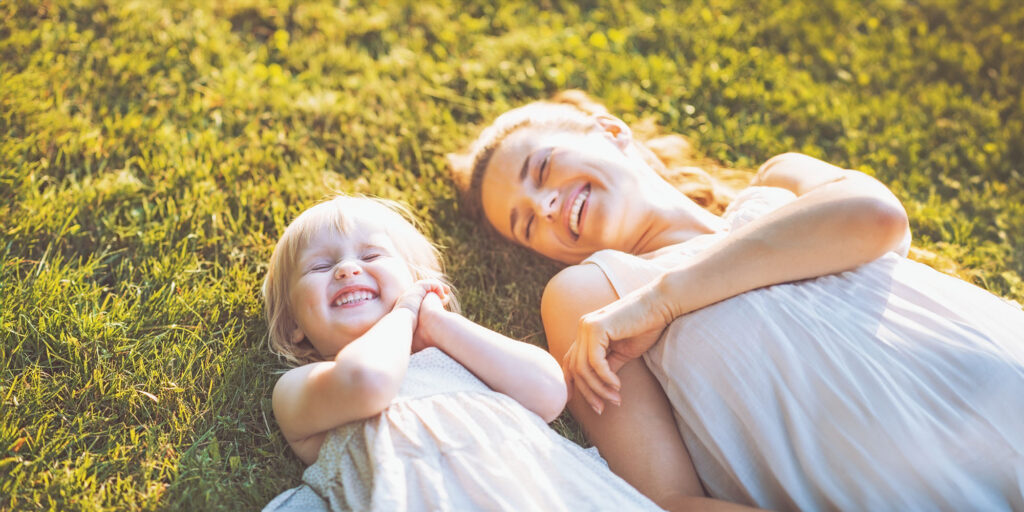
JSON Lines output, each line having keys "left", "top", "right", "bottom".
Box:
{"left": 264, "top": 348, "right": 659, "bottom": 511}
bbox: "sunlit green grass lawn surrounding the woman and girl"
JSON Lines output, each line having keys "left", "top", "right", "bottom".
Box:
{"left": 0, "top": 0, "right": 1024, "bottom": 510}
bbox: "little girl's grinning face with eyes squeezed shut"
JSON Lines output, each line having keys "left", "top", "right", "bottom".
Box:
{"left": 289, "top": 222, "right": 415, "bottom": 357}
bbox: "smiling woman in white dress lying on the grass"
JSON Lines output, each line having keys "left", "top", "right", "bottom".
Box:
{"left": 453, "top": 92, "right": 1024, "bottom": 510}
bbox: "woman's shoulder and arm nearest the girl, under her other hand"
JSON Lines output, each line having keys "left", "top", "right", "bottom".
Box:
{"left": 541, "top": 264, "right": 750, "bottom": 511}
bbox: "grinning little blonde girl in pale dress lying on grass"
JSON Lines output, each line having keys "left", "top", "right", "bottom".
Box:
{"left": 264, "top": 197, "right": 656, "bottom": 510}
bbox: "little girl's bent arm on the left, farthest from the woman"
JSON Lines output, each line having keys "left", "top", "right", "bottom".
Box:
{"left": 272, "top": 282, "right": 441, "bottom": 464}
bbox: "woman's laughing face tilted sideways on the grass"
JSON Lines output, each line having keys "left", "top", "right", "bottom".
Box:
{"left": 480, "top": 122, "right": 649, "bottom": 263}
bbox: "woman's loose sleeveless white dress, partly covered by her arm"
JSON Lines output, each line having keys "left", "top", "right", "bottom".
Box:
{"left": 587, "top": 187, "right": 1024, "bottom": 511}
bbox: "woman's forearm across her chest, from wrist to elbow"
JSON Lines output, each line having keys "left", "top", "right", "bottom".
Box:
{"left": 648, "top": 176, "right": 907, "bottom": 317}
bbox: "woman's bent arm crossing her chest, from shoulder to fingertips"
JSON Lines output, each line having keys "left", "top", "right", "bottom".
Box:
{"left": 569, "top": 154, "right": 907, "bottom": 407}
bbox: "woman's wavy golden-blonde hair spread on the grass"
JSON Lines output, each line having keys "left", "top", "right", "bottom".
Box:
{"left": 449, "top": 90, "right": 753, "bottom": 222}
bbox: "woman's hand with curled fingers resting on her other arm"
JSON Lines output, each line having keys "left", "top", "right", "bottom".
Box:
{"left": 562, "top": 282, "right": 675, "bottom": 414}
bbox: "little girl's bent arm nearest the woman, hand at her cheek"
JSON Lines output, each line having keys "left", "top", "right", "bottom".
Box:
{"left": 416, "top": 296, "right": 566, "bottom": 423}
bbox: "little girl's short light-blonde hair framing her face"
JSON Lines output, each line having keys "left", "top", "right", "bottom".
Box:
{"left": 263, "top": 196, "right": 459, "bottom": 366}
